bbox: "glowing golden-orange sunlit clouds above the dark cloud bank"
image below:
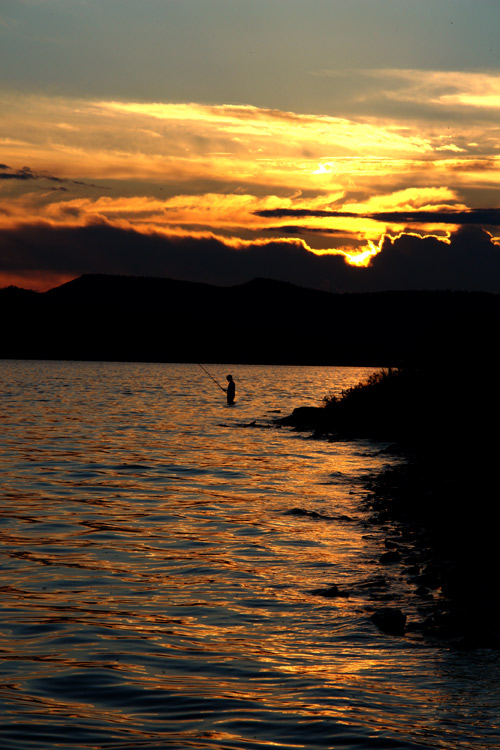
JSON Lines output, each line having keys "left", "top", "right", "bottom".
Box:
{"left": 0, "top": 84, "right": 500, "bottom": 290}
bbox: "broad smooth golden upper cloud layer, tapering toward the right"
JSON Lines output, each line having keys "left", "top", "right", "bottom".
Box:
{"left": 0, "top": 88, "right": 458, "bottom": 197}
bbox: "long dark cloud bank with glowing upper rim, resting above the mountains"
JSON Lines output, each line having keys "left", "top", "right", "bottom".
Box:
{"left": 0, "top": 224, "right": 500, "bottom": 293}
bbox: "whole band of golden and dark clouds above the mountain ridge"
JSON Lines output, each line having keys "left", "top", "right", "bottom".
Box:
{"left": 0, "top": 88, "right": 500, "bottom": 291}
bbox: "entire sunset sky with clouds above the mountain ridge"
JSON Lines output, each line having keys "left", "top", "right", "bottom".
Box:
{"left": 0, "top": 0, "right": 500, "bottom": 293}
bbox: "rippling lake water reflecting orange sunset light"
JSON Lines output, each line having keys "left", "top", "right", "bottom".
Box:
{"left": 0, "top": 362, "right": 500, "bottom": 750}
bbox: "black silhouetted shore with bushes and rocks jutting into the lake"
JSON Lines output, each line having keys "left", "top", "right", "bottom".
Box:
{"left": 283, "top": 360, "right": 500, "bottom": 648}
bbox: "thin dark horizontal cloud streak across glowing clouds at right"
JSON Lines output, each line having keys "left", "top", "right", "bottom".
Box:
{"left": 255, "top": 208, "right": 500, "bottom": 227}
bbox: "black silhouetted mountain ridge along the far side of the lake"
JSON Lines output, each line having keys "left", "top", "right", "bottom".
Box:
{"left": 0, "top": 275, "right": 500, "bottom": 366}
